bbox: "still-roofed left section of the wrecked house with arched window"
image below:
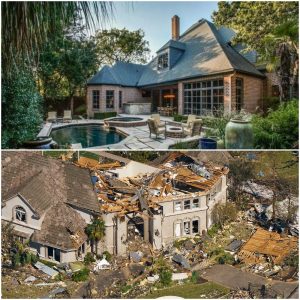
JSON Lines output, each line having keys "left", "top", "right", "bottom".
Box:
{"left": 1, "top": 152, "right": 100, "bottom": 262}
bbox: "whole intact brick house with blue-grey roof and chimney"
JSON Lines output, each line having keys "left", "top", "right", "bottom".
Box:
{"left": 87, "top": 16, "right": 268, "bottom": 117}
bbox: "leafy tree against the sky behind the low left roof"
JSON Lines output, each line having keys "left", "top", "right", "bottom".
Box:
{"left": 95, "top": 28, "right": 150, "bottom": 65}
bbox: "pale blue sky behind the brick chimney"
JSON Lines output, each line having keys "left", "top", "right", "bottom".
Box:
{"left": 98, "top": 1, "right": 218, "bottom": 55}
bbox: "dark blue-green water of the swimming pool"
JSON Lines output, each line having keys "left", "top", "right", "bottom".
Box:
{"left": 51, "top": 125, "right": 125, "bottom": 148}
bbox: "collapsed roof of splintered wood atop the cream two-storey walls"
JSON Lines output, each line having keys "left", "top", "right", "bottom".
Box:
{"left": 85, "top": 152, "right": 229, "bottom": 217}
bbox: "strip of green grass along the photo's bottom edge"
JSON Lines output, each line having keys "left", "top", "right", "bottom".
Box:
{"left": 140, "top": 282, "right": 229, "bottom": 299}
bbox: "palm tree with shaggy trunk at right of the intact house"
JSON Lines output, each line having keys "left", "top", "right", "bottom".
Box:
{"left": 262, "top": 20, "right": 299, "bottom": 101}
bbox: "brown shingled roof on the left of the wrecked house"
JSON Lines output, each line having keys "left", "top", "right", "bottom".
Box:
{"left": 2, "top": 152, "right": 100, "bottom": 250}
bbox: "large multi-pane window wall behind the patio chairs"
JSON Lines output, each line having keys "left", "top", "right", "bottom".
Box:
{"left": 184, "top": 79, "right": 224, "bottom": 115}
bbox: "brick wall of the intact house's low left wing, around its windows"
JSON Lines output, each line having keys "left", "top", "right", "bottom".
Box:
{"left": 87, "top": 85, "right": 151, "bottom": 118}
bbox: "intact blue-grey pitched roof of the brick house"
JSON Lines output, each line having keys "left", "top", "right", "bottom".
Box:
{"left": 88, "top": 19, "right": 264, "bottom": 87}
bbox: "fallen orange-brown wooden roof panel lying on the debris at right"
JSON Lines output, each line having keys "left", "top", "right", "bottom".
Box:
{"left": 238, "top": 228, "right": 298, "bottom": 264}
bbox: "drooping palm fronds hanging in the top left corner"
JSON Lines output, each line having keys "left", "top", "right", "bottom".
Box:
{"left": 1, "top": 1, "right": 113, "bottom": 71}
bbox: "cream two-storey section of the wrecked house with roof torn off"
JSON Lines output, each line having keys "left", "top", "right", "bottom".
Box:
{"left": 93, "top": 153, "right": 228, "bottom": 255}
